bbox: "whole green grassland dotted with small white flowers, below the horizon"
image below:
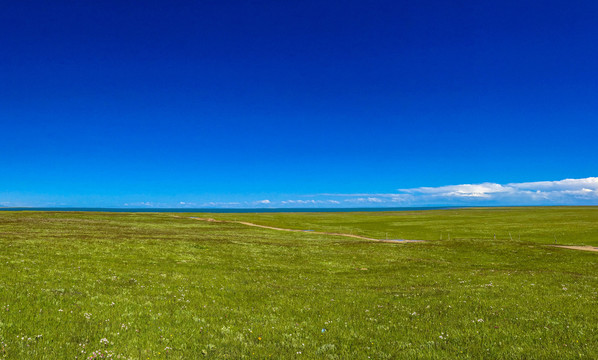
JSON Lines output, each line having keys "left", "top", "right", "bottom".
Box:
{"left": 0, "top": 207, "right": 598, "bottom": 359}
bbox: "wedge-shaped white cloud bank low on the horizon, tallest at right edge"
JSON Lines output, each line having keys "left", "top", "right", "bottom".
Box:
{"left": 170, "top": 177, "right": 598, "bottom": 208}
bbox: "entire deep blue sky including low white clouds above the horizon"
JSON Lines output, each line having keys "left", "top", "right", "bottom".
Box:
{"left": 0, "top": 0, "right": 598, "bottom": 207}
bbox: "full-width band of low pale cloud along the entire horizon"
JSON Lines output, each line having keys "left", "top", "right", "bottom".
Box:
{"left": 0, "top": 177, "right": 598, "bottom": 209}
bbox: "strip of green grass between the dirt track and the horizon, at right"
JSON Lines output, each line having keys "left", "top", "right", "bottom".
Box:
{"left": 202, "top": 206, "right": 598, "bottom": 246}
